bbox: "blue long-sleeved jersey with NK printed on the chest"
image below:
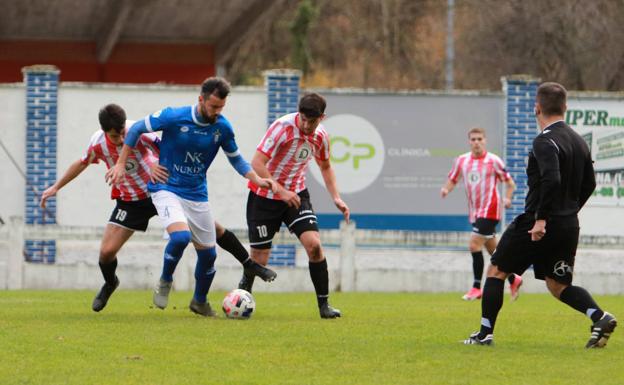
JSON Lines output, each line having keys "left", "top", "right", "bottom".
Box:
{"left": 125, "top": 105, "right": 251, "bottom": 202}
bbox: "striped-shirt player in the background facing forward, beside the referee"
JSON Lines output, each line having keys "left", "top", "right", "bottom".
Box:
{"left": 440, "top": 128, "right": 522, "bottom": 301}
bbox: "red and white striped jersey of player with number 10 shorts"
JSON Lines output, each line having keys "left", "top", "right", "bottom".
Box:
{"left": 248, "top": 113, "right": 329, "bottom": 199}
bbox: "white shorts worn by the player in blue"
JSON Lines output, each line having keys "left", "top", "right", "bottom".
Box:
{"left": 152, "top": 190, "right": 217, "bottom": 247}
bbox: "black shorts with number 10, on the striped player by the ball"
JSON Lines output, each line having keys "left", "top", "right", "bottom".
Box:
{"left": 247, "top": 190, "right": 318, "bottom": 249}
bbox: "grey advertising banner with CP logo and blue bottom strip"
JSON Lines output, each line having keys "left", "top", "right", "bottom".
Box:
{"left": 306, "top": 94, "right": 504, "bottom": 231}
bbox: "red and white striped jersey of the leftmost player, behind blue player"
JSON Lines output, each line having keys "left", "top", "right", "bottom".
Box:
{"left": 80, "top": 121, "right": 160, "bottom": 201}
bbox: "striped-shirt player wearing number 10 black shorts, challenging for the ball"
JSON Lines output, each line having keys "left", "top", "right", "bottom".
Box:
{"left": 239, "top": 93, "right": 349, "bottom": 318}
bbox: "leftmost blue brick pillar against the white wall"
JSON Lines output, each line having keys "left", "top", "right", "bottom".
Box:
{"left": 22, "top": 65, "right": 60, "bottom": 263}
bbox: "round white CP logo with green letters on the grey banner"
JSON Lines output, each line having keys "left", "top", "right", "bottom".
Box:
{"left": 312, "top": 114, "right": 385, "bottom": 193}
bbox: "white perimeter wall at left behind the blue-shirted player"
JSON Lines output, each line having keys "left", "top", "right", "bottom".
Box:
{"left": 0, "top": 83, "right": 267, "bottom": 228}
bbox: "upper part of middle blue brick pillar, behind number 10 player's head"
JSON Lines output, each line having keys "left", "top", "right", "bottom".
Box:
{"left": 264, "top": 69, "right": 301, "bottom": 126}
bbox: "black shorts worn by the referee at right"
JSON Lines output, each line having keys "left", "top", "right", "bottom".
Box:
{"left": 491, "top": 213, "right": 579, "bottom": 285}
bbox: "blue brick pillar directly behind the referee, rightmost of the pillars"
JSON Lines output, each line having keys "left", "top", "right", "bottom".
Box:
{"left": 501, "top": 75, "right": 540, "bottom": 223}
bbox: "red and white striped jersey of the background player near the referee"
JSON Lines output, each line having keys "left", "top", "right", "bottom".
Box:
{"left": 448, "top": 152, "right": 511, "bottom": 223}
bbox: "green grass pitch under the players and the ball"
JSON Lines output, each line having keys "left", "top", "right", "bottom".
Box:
{"left": 0, "top": 290, "right": 624, "bottom": 385}
